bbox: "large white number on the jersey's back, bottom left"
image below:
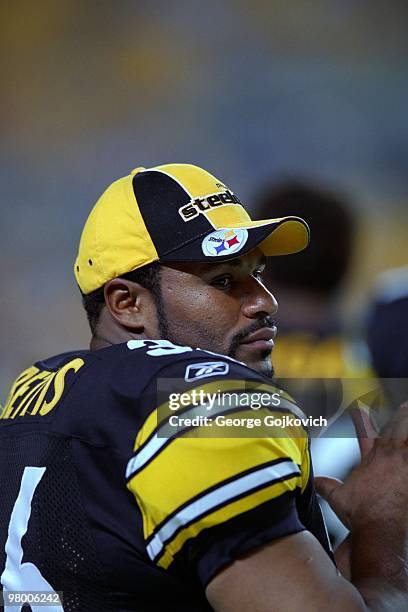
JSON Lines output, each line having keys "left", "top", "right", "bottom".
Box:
{"left": 1, "top": 467, "right": 64, "bottom": 612}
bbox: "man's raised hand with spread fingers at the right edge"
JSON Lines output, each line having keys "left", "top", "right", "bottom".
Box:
{"left": 316, "top": 403, "right": 408, "bottom": 588}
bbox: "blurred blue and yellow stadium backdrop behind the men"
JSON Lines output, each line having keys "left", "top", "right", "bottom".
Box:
{"left": 0, "top": 0, "right": 408, "bottom": 401}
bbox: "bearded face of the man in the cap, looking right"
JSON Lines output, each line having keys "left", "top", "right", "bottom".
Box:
{"left": 158, "top": 249, "right": 278, "bottom": 376}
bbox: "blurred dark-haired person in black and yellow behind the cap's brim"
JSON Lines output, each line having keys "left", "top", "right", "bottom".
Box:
{"left": 255, "top": 179, "right": 370, "bottom": 542}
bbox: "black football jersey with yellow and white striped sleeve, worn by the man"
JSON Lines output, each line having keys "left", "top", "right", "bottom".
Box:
{"left": 0, "top": 340, "right": 331, "bottom": 612}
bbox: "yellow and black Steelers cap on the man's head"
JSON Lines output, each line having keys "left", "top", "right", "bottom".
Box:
{"left": 74, "top": 164, "right": 309, "bottom": 294}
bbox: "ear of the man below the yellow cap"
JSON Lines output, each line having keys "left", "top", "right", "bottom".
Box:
{"left": 104, "top": 278, "right": 154, "bottom": 333}
